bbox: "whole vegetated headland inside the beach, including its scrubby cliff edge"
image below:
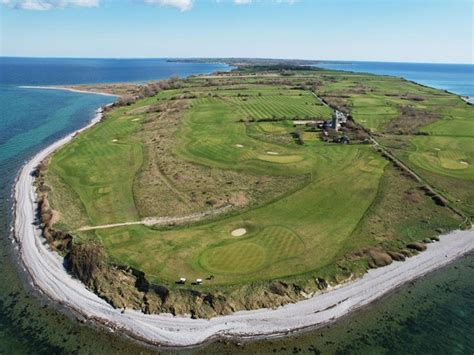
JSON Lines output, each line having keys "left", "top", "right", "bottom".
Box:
{"left": 37, "top": 66, "right": 474, "bottom": 317}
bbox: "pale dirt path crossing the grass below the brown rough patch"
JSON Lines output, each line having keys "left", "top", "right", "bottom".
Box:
{"left": 78, "top": 205, "right": 232, "bottom": 231}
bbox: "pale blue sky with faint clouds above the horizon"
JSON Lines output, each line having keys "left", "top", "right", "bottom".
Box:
{"left": 0, "top": 0, "right": 474, "bottom": 64}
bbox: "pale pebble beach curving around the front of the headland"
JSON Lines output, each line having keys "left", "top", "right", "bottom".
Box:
{"left": 14, "top": 99, "right": 474, "bottom": 346}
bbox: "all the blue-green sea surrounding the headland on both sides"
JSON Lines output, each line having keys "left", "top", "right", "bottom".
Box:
{"left": 0, "top": 58, "right": 474, "bottom": 354}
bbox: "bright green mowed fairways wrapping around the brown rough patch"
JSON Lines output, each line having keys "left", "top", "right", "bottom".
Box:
{"left": 52, "top": 82, "right": 392, "bottom": 286}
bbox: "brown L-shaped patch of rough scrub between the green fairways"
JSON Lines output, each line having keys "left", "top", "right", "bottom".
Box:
{"left": 133, "top": 100, "right": 306, "bottom": 217}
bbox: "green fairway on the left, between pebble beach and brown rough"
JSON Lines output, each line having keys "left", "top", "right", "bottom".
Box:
{"left": 49, "top": 105, "right": 143, "bottom": 224}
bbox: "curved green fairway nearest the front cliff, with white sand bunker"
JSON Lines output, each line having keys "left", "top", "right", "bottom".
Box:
{"left": 97, "top": 143, "right": 386, "bottom": 284}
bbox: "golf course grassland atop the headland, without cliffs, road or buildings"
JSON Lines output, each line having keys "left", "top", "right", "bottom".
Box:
{"left": 47, "top": 72, "right": 474, "bottom": 287}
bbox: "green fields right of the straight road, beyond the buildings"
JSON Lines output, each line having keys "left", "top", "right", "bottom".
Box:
{"left": 314, "top": 69, "right": 474, "bottom": 216}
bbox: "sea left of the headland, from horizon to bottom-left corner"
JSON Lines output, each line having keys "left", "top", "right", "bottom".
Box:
{"left": 0, "top": 57, "right": 230, "bottom": 354}
